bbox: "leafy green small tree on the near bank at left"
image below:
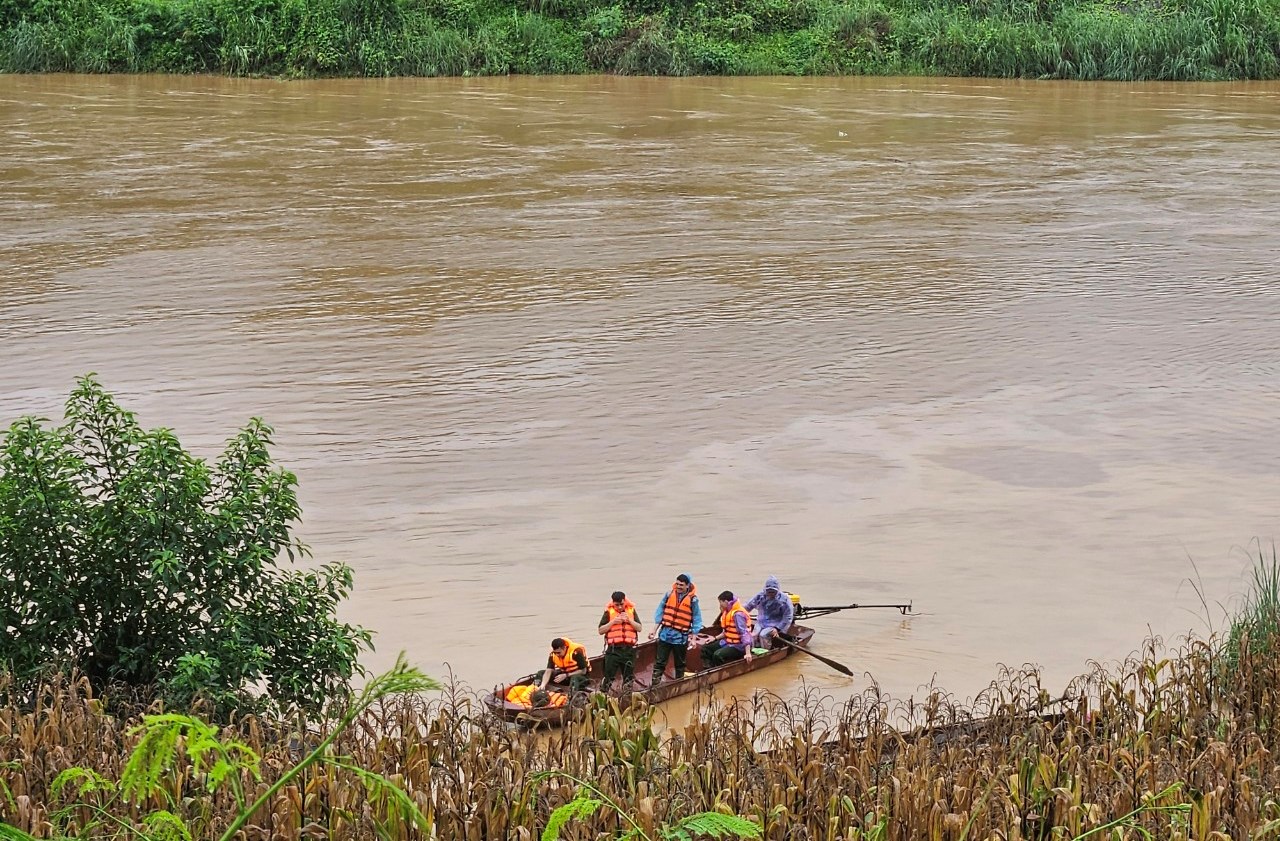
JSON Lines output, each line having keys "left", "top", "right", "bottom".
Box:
{"left": 0, "top": 375, "right": 372, "bottom": 713}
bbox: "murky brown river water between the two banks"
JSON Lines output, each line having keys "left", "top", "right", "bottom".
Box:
{"left": 0, "top": 76, "right": 1280, "bottom": 696}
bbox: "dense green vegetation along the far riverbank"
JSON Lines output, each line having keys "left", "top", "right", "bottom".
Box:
{"left": 0, "top": 0, "right": 1280, "bottom": 79}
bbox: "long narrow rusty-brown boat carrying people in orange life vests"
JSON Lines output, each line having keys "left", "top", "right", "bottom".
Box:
{"left": 484, "top": 625, "right": 813, "bottom": 727}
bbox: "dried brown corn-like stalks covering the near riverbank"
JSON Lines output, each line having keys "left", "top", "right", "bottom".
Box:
{"left": 0, "top": 550, "right": 1280, "bottom": 841}
